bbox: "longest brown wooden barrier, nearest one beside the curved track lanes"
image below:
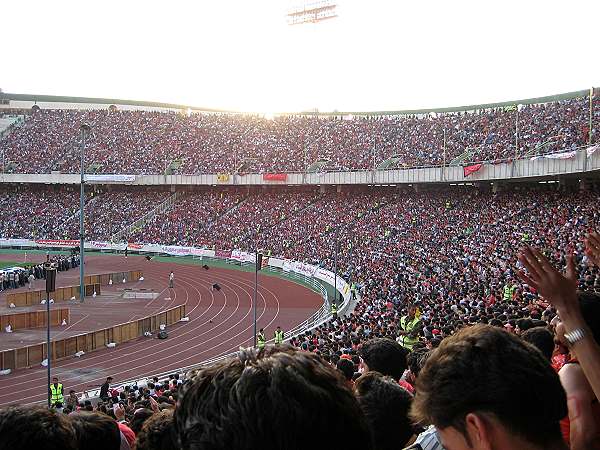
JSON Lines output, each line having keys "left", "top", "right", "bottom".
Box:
{"left": 0, "top": 305, "right": 185, "bottom": 370}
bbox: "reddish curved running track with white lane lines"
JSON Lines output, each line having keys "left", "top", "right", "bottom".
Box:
{"left": 0, "top": 255, "right": 323, "bottom": 406}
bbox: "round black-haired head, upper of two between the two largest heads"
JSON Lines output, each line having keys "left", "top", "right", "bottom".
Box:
{"left": 360, "top": 338, "right": 408, "bottom": 381}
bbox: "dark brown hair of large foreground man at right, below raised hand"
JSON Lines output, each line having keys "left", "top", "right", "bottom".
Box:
{"left": 411, "top": 325, "right": 567, "bottom": 447}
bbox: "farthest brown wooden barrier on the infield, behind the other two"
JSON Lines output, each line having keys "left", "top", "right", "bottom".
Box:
{"left": 6, "top": 270, "right": 143, "bottom": 307}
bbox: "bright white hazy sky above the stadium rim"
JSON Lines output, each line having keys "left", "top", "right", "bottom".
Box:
{"left": 0, "top": 0, "right": 600, "bottom": 112}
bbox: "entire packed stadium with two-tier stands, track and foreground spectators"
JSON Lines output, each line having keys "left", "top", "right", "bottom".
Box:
{"left": 0, "top": 2, "right": 600, "bottom": 450}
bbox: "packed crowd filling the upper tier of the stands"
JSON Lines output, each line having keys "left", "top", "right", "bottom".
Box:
{"left": 0, "top": 93, "right": 600, "bottom": 174}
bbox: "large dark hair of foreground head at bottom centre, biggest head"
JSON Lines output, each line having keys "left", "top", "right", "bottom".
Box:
{"left": 175, "top": 345, "right": 371, "bottom": 450}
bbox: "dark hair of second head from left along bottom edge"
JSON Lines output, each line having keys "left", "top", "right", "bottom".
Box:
{"left": 69, "top": 412, "right": 121, "bottom": 450}
